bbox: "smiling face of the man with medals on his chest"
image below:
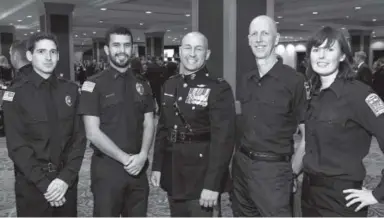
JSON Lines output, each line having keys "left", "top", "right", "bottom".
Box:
{"left": 180, "top": 33, "right": 211, "bottom": 74}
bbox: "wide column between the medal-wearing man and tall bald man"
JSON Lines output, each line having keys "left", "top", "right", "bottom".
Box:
{"left": 192, "top": 0, "right": 268, "bottom": 104}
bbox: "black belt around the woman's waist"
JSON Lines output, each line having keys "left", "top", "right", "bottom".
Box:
{"left": 304, "top": 173, "right": 363, "bottom": 189}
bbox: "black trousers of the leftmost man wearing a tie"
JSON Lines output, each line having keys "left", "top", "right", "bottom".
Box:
{"left": 15, "top": 175, "right": 77, "bottom": 217}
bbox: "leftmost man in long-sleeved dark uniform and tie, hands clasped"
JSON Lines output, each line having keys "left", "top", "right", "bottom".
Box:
{"left": 3, "top": 33, "right": 86, "bottom": 217}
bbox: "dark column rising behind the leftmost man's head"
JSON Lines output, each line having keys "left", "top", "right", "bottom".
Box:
{"left": 40, "top": 2, "right": 75, "bottom": 80}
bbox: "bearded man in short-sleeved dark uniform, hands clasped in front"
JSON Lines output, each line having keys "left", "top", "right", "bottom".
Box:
{"left": 79, "top": 27, "right": 154, "bottom": 217}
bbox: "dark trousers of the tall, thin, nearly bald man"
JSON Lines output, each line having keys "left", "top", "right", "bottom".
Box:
{"left": 232, "top": 151, "right": 293, "bottom": 217}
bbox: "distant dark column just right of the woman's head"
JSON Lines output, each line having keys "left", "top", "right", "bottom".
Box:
{"left": 348, "top": 29, "right": 372, "bottom": 63}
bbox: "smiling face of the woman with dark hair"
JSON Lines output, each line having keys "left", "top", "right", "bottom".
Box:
{"left": 310, "top": 39, "right": 345, "bottom": 76}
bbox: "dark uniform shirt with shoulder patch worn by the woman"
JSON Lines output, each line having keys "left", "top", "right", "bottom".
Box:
{"left": 303, "top": 79, "right": 384, "bottom": 200}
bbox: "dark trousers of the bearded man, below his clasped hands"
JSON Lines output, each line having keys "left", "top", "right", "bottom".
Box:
{"left": 91, "top": 155, "right": 149, "bottom": 217}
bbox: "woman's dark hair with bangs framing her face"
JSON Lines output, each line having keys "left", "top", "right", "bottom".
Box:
{"left": 306, "top": 26, "right": 355, "bottom": 93}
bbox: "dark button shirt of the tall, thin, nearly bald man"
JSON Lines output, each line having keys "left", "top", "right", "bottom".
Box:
{"left": 239, "top": 61, "right": 306, "bottom": 155}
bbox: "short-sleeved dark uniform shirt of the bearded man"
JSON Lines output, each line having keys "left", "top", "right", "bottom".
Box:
{"left": 78, "top": 67, "right": 154, "bottom": 154}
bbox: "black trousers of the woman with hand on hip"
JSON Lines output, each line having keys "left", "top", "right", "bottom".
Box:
{"left": 301, "top": 175, "right": 368, "bottom": 217}
